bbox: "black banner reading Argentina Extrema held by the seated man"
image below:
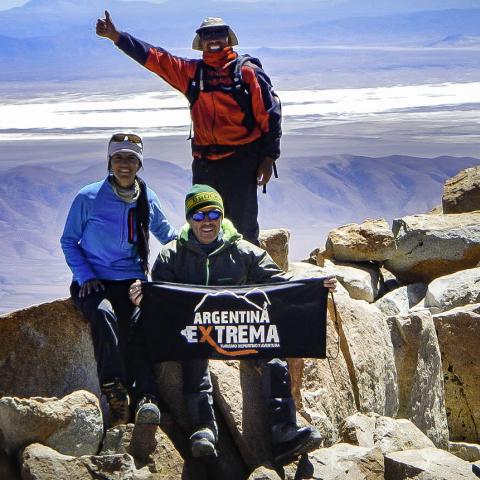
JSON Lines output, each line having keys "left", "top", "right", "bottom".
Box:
{"left": 141, "top": 278, "right": 328, "bottom": 361}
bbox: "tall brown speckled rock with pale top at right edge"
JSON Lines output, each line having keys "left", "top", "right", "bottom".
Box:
{"left": 433, "top": 303, "right": 480, "bottom": 443}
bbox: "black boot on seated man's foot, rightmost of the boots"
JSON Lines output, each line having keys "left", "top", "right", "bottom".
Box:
{"left": 272, "top": 424, "right": 322, "bottom": 465}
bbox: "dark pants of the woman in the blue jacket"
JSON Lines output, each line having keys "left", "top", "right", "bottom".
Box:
{"left": 70, "top": 280, "right": 156, "bottom": 396}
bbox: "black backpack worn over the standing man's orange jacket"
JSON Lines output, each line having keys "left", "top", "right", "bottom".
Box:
{"left": 186, "top": 55, "right": 280, "bottom": 133}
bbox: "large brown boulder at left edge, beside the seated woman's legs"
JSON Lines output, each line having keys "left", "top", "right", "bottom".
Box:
{"left": 0, "top": 300, "right": 100, "bottom": 398}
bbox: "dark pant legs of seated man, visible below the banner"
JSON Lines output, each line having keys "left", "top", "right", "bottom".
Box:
{"left": 182, "top": 358, "right": 296, "bottom": 435}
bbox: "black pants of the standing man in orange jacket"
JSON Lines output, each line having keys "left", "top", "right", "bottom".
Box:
{"left": 192, "top": 143, "right": 260, "bottom": 245}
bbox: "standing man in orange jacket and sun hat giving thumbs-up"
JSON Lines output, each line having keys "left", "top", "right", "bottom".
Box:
{"left": 96, "top": 11, "right": 282, "bottom": 244}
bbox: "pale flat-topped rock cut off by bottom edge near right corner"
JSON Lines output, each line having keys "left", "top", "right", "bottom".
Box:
{"left": 385, "top": 448, "right": 478, "bottom": 480}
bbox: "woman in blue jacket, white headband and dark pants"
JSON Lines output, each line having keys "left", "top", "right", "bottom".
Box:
{"left": 60, "top": 133, "right": 177, "bottom": 426}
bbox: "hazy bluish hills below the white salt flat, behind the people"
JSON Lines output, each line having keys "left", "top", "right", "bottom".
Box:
{"left": 0, "top": 149, "right": 479, "bottom": 311}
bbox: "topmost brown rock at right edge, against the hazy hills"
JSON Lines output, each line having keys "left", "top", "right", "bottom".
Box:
{"left": 442, "top": 166, "right": 480, "bottom": 213}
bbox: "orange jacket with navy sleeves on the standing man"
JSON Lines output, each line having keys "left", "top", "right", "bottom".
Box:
{"left": 117, "top": 33, "right": 282, "bottom": 160}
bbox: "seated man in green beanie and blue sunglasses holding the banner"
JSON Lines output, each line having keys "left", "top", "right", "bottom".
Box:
{"left": 130, "top": 185, "right": 336, "bottom": 463}
